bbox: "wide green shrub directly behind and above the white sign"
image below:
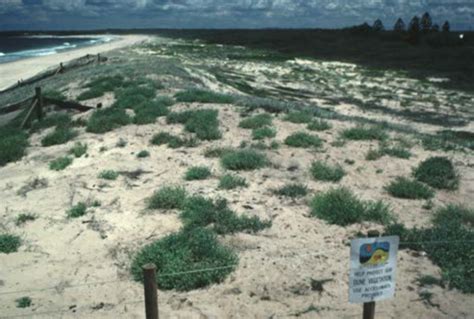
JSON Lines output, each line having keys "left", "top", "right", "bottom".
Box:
{"left": 311, "top": 187, "right": 393, "bottom": 226}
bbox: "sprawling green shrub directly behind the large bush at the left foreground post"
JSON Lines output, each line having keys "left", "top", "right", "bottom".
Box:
{"left": 180, "top": 196, "right": 271, "bottom": 234}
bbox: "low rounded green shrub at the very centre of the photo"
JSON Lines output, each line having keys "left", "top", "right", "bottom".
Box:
{"left": 221, "top": 150, "right": 268, "bottom": 171}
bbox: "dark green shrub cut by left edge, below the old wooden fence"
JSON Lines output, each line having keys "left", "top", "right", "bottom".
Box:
{"left": 0, "top": 127, "right": 28, "bottom": 166}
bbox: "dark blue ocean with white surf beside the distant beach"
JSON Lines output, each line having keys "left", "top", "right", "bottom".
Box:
{"left": 0, "top": 35, "right": 114, "bottom": 63}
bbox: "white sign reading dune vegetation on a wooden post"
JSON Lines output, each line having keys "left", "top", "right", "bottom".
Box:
{"left": 349, "top": 236, "right": 400, "bottom": 303}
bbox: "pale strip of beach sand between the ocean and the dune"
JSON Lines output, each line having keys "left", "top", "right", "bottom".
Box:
{"left": 0, "top": 35, "right": 150, "bottom": 91}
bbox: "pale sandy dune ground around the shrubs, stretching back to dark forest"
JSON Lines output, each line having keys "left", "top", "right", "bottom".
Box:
{"left": 0, "top": 38, "right": 474, "bottom": 318}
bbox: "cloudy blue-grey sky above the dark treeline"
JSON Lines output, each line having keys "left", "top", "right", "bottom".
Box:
{"left": 0, "top": 0, "right": 474, "bottom": 31}
